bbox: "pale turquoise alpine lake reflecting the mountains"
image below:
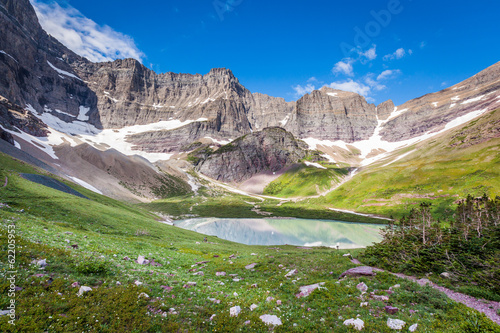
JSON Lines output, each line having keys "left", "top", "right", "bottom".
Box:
{"left": 174, "top": 218, "right": 384, "bottom": 249}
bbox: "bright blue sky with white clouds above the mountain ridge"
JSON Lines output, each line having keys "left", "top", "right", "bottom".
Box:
{"left": 31, "top": 0, "right": 500, "bottom": 105}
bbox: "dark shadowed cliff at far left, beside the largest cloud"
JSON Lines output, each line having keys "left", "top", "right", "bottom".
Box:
{"left": 0, "top": 0, "right": 100, "bottom": 127}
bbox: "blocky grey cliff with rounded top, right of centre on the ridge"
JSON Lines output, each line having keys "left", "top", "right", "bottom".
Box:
{"left": 291, "top": 87, "right": 377, "bottom": 142}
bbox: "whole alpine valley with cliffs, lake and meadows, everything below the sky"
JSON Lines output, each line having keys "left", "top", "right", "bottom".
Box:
{"left": 0, "top": 0, "right": 500, "bottom": 332}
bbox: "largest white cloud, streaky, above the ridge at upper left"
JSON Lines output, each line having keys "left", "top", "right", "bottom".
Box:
{"left": 31, "top": 0, "right": 145, "bottom": 62}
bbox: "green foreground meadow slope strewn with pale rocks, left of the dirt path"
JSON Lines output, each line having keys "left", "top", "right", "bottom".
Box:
{"left": 0, "top": 155, "right": 498, "bottom": 332}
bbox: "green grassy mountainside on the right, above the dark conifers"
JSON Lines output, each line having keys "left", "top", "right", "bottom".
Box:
{"left": 315, "top": 110, "right": 500, "bottom": 217}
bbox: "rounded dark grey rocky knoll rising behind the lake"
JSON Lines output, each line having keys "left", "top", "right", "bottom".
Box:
{"left": 196, "top": 127, "right": 307, "bottom": 182}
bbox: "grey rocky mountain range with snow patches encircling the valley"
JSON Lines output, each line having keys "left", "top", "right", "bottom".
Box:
{"left": 0, "top": 0, "right": 500, "bottom": 200}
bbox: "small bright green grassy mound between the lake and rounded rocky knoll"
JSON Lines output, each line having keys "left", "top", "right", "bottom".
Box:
{"left": 264, "top": 163, "right": 349, "bottom": 198}
